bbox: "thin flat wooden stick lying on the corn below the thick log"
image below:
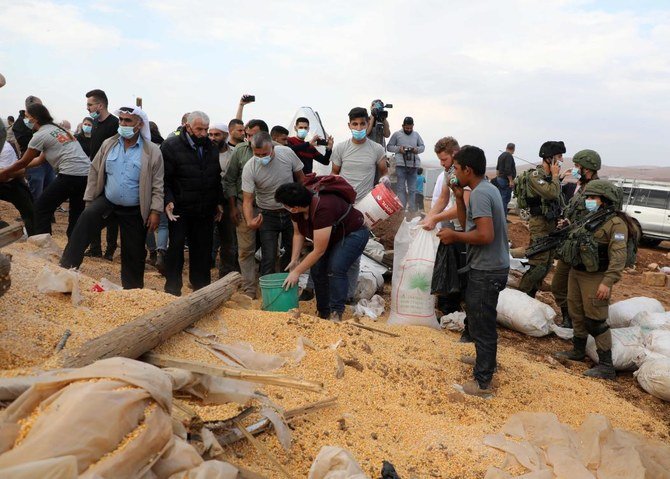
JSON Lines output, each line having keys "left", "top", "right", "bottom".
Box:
{"left": 140, "top": 353, "right": 323, "bottom": 393}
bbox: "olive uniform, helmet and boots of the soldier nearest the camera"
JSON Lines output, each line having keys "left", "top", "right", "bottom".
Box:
{"left": 557, "top": 180, "right": 628, "bottom": 379}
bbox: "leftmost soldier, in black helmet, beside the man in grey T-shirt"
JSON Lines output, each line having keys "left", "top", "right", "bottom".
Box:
{"left": 515, "top": 141, "right": 565, "bottom": 298}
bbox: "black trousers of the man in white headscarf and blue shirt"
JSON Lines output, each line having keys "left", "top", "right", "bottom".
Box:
{"left": 60, "top": 194, "right": 147, "bottom": 289}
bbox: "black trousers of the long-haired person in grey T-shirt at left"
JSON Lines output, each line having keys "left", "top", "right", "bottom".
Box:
{"left": 35, "top": 174, "right": 88, "bottom": 238}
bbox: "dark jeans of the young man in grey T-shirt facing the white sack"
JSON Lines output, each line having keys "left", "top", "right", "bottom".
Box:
{"left": 465, "top": 268, "right": 509, "bottom": 389}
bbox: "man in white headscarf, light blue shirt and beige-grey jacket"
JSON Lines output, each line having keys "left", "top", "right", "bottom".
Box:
{"left": 60, "top": 107, "right": 163, "bottom": 289}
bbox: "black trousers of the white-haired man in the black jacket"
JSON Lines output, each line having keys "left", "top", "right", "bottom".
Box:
{"left": 165, "top": 214, "right": 214, "bottom": 296}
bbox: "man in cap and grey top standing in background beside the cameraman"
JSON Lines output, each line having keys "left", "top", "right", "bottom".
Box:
{"left": 386, "top": 116, "right": 426, "bottom": 211}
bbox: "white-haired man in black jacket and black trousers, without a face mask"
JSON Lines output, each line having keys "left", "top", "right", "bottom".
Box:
{"left": 161, "top": 111, "right": 223, "bottom": 296}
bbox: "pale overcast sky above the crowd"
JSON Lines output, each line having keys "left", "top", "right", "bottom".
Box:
{"left": 0, "top": 0, "right": 670, "bottom": 166}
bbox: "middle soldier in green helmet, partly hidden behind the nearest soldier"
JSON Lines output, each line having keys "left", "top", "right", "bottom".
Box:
{"left": 551, "top": 150, "right": 601, "bottom": 328}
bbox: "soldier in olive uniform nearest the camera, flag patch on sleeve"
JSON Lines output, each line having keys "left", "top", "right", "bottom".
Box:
{"left": 556, "top": 180, "right": 637, "bottom": 379}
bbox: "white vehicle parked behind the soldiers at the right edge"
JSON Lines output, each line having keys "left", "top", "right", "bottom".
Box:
{"left": 609, "top": 178, "right": 670, "bottom": 246}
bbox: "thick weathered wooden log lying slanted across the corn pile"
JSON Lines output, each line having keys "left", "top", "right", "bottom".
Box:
{"left": 62, "top": 273, "right": 242, "bottom": 368}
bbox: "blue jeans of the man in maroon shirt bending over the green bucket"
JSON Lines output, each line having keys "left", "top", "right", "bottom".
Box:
{"left": 311, "top": 227, "right": 370, "bottom": 315}
